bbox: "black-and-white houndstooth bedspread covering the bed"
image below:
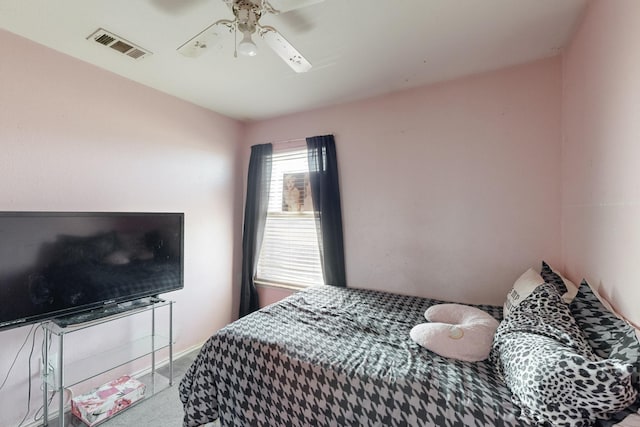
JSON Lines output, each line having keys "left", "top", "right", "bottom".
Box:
{"left": 179, "top": 287, "right": 526, "bottom": 427}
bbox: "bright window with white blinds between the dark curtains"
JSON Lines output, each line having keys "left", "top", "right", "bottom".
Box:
{"left": 255, "top": 148, "right": 324, "bottom": 286}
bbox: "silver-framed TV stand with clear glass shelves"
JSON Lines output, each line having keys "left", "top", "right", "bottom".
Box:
{"left": 42, "top": 298, "right": 174, "bottom": 427}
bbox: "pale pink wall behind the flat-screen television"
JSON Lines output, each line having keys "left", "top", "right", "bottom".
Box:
{"left": 0, "top": 31, "right": 243, "bottom": 426}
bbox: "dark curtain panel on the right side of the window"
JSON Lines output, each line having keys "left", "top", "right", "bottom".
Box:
{"left": 307, "top": 135, "right": 347, "bottom": 287}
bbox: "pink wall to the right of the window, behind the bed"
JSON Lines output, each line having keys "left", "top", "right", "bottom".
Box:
{"left": 244, "top": 58, "right": 561, "bottom": 310}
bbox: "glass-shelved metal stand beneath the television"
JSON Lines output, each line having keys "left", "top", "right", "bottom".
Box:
{"left": 42, "top": 297, "right": 173, "bottom": 427}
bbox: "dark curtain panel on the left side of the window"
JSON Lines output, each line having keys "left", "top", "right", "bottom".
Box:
{"left": 240, "top": 144, "right": 273, "bottom": 317}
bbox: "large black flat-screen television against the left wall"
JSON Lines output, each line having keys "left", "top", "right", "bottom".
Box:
{"left": 0, "top": 212, "right": 184, "bottom": 330}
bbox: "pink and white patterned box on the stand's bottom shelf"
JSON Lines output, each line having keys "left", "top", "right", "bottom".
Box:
{"left": 71, "top": 375, "right": 145, "bottom": 427}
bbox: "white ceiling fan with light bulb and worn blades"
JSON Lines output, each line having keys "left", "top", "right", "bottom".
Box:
{"left": 178, "top": 0, "right": 324, "bottom": 73}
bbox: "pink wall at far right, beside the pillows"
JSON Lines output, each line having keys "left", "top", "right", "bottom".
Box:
{"left": 562, "top": 0, "right": 640, "bottom": 324}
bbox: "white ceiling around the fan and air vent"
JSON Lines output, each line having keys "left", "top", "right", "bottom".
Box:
{"left": 0, "top": 0, "right": 588, "bottom": 120}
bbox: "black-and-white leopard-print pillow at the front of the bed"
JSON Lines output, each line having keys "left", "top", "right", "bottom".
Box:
{"left": 491, "top": 284, "right": 637, "bottom": 427}
